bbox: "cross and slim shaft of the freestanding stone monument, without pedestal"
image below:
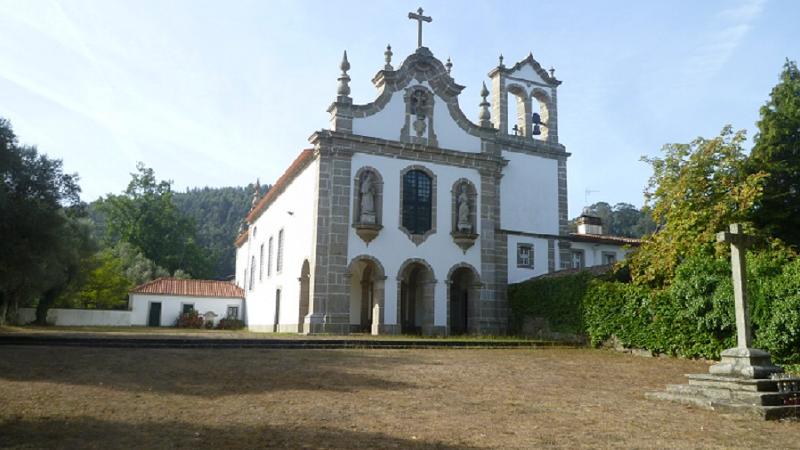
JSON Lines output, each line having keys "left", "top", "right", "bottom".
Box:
{"left": 717, "top": 223, "right": 754, "bottom": 348}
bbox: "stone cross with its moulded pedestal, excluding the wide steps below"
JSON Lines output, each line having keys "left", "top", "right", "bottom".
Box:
{"left": 709, "top": 223, "right": 783, "bottom": 378}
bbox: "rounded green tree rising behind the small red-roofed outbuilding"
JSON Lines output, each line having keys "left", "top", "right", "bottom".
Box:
{"left": 98, "top": 163, "right": 210, "bottom": 278}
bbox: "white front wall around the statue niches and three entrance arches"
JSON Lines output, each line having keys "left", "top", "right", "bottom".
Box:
{"left": 347, "top": 153, "right": 481, "bottom": 326}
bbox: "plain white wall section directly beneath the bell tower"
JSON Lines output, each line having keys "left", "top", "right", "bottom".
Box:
{"left": 500, "top": 151, "right": 558, "bottom": 236}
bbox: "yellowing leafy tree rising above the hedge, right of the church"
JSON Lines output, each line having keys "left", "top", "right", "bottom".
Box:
{"left": 629, "top": 126, "right": 766, "bottom": 286}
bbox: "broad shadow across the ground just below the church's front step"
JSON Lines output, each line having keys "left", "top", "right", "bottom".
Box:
{"left": 0, "top": 347, "right": 423, "bottom": 398}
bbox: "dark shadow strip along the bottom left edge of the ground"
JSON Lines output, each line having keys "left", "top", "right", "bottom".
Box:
{"left": 0, "top": 417, "right": 471, "bottom": 450}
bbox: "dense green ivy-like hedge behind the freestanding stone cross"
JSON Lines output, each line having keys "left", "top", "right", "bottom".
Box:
{"left": 509, "top": 250, "right": 800, "bottom": 364}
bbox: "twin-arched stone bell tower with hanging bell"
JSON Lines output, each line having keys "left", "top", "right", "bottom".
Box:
{"left": 489, "top": 53, "right": 561, "bottom": 144}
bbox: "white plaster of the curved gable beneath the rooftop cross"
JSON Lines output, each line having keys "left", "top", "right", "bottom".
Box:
{"left": 353, "top": 83, "right": 481, "bottom": 153}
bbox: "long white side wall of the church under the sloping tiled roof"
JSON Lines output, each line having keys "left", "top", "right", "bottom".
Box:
{"left": 236, "top": 160, "right": 319, "bottom": 331}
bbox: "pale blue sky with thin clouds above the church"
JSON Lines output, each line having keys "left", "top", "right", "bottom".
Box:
{"left": 0, "top": 0, "right": 800, "bottom": 216}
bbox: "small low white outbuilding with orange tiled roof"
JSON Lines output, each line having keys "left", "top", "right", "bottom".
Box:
{"left": 128, "top": 278, "right": 244, "bottom": 327}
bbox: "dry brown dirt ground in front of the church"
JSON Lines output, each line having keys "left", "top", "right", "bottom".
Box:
{"left": 0, "top": 346, "right": 800, "bottom": 449}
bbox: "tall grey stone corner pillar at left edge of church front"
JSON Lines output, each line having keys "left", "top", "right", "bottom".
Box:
{"left": 307, "top": 143, "right": 352, "bottom": 334}
